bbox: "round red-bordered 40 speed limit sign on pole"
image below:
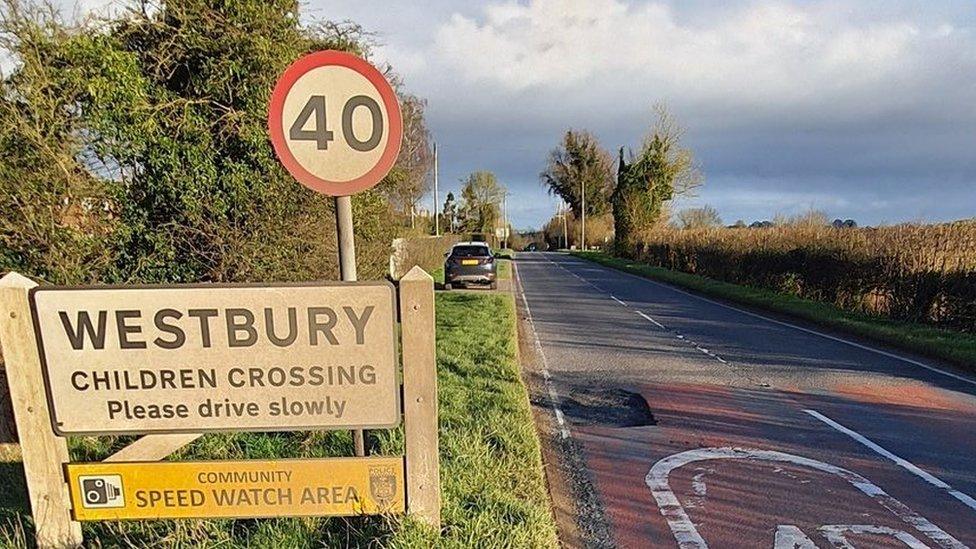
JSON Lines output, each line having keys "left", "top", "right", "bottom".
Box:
{"left": 268, "top": 51, "right": 403, "bottom": 196}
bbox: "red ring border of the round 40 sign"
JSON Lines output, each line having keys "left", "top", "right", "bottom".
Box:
{"left": 268, "top": 50, "right": 403, "bottom": 196}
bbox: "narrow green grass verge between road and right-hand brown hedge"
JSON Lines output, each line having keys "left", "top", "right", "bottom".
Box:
{"left": 572, "top": 252, "right": 976, "bottom": 371}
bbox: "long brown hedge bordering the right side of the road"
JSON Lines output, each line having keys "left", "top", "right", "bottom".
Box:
{"left": 618, "top": 223, "right": 976, "bottom": 333}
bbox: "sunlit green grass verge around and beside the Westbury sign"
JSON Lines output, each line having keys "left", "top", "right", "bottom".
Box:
{"left": 0, "top": 293, "right": 557, "bottom": 549}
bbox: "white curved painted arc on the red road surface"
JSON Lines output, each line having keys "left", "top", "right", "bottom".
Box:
{"left": 644, "top": 447, "right": 968, "bottom": 549}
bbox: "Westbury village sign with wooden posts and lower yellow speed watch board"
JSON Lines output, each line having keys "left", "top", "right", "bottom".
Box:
{"left": 0, "top": 267, "right": 440, "bottom": 549}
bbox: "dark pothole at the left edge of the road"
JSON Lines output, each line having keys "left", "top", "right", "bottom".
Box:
{"left": 559, "top": 388, "right": 657, "bottom": 427}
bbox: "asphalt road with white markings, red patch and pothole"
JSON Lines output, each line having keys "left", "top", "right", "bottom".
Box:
{"left": 516, "top": 253, "right": 976, "bottom": 549}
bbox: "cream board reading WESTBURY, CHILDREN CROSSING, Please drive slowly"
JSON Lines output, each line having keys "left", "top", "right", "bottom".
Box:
{"left": 32, "top": 282, "right": 399, "bottom": 434}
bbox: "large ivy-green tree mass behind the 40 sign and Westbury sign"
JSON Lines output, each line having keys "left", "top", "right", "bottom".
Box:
{"left": 0, "top": 0, "right": 414, "bottom": 283}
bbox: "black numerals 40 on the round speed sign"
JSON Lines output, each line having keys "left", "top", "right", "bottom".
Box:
{"left": 288, "top": 95, "right": 383, "bottom": 152}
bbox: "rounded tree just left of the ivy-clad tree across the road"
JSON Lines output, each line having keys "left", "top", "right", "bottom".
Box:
{"left": 539, "top": 130, "right": 613, "bottom": 217}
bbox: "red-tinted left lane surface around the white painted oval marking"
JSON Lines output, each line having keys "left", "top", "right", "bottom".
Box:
{"left": 574, "top": 385, "right": 969, "bottom": 549}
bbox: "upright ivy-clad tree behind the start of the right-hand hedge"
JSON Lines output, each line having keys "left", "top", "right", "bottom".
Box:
{"left": 611, "top": 105, "right": 702, "bottom": 250}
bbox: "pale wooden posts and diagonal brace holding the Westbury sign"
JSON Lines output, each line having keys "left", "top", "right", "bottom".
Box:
{"left": 0, "top": 267, "right": 441, "bottom": 549}
